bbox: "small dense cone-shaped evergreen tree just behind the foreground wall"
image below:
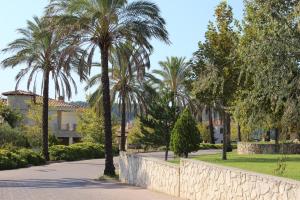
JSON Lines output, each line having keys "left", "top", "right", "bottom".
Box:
{"left": 171, "top": 109, "right": 202, "bottom": 158}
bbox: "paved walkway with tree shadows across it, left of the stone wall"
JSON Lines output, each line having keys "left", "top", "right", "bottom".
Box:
{"left": 0, "top": 159, "right": 177, "bottom": 200}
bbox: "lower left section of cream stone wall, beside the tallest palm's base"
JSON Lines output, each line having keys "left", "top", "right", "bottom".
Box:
{"left": 119, "top": 152, "right": 179, "bottom": 197}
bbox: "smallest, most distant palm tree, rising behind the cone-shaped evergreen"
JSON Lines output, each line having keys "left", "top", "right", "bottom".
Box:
{"left": 153, "top": 57, "right": 191, "bottom": 108}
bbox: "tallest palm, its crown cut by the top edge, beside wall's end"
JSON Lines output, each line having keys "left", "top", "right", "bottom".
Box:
{"left": 48, "top": 0, "right": 168, "bottom": 175}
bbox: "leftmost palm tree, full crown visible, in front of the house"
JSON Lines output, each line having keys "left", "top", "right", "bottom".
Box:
{"left": 2, "top": 17, "right": 80, "bottom": 160}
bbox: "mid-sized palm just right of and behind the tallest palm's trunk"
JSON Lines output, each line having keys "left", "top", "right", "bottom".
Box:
{"left": 86, "top": 45, "right": 150, "bottom": 151}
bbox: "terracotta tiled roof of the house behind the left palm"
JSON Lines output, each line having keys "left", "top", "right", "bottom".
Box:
{"left": 2, "top": 90, "right": 85, "bottom": 109}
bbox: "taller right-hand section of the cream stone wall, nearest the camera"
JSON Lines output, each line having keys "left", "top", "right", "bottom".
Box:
{"left": 180, "top": 160, "right": 300, "bottom": 200}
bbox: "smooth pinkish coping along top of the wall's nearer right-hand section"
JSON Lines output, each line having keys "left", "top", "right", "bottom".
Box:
{"left": 180, "top": 158, "right": 300, "bottom": 187}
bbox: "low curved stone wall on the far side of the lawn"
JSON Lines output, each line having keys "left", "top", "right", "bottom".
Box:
{"left": 237, "top": 142, "right": 300, "bottom": 154}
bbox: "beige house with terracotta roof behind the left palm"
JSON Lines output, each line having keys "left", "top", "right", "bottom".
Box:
{"left": 2, "top": 90, "right": 84, "bottom": 145}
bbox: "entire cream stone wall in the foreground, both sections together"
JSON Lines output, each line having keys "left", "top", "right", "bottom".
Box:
{"left": 120, "top": 153, "right": 300, "bottom": 200}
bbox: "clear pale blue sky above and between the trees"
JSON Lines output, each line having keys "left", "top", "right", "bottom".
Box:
{"left": 0, "top": 0, "right": 243, "bottom": 101}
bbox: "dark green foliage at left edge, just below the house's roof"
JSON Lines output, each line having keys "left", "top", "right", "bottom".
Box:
{"left": 0, "top": 101, "right": 23, "bottom": 128}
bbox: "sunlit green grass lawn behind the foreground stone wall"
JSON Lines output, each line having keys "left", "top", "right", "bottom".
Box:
{"left": 170, "top": 152, "right": 300, "bottom": 181}
